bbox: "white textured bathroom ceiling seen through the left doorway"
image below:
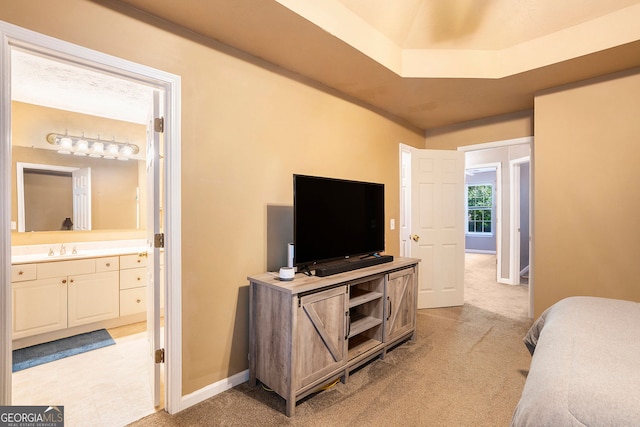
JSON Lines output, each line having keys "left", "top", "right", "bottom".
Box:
{"left": 11, "top": 49, "right": 152, "bottom": 124}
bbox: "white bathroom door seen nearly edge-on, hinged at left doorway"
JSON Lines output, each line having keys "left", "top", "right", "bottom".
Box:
{"left": 146, "top": 91, "right": 161, "bottom": 406}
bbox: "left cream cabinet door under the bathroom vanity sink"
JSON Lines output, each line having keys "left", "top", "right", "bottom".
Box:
{"left": 12, "top": 277, "right": 67, "bottom": 339}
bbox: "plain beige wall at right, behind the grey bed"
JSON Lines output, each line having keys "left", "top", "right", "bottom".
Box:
{"left": 534, "top": 69, "right": 640, "bottom": 315}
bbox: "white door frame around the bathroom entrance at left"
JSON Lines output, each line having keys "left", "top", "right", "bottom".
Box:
{"left": 0, "top": 21, "right": 182, "bottom": 413}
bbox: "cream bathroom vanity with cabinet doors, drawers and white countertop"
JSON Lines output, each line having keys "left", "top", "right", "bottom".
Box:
{"left": 11, "top": 242, "right": 147, "bottom": 349}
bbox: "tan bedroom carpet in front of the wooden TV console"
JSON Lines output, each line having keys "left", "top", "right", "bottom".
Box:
{"left": 132, "top": 256, "right": 531, "bottom": 427}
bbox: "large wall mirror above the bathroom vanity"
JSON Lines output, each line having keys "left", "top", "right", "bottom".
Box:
{"left": 13, "top": 146, "right": 145, "bottom": 232}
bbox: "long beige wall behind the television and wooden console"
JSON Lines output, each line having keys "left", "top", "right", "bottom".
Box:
{"left": 0, "top": 0, "right": 424, "bottom": 394}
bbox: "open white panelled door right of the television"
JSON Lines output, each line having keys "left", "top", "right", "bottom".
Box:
{"left": 410, "top": 150, "right": 465, "bottom": 308}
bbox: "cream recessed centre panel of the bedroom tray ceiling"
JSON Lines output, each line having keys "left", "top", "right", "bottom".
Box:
{"left": 337, "top": 0, "right": 637, "bottom": 50}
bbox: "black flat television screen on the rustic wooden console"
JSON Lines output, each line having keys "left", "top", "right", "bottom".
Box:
{"left": 293, "top": 175, "right": 385, "bottom": 266}
